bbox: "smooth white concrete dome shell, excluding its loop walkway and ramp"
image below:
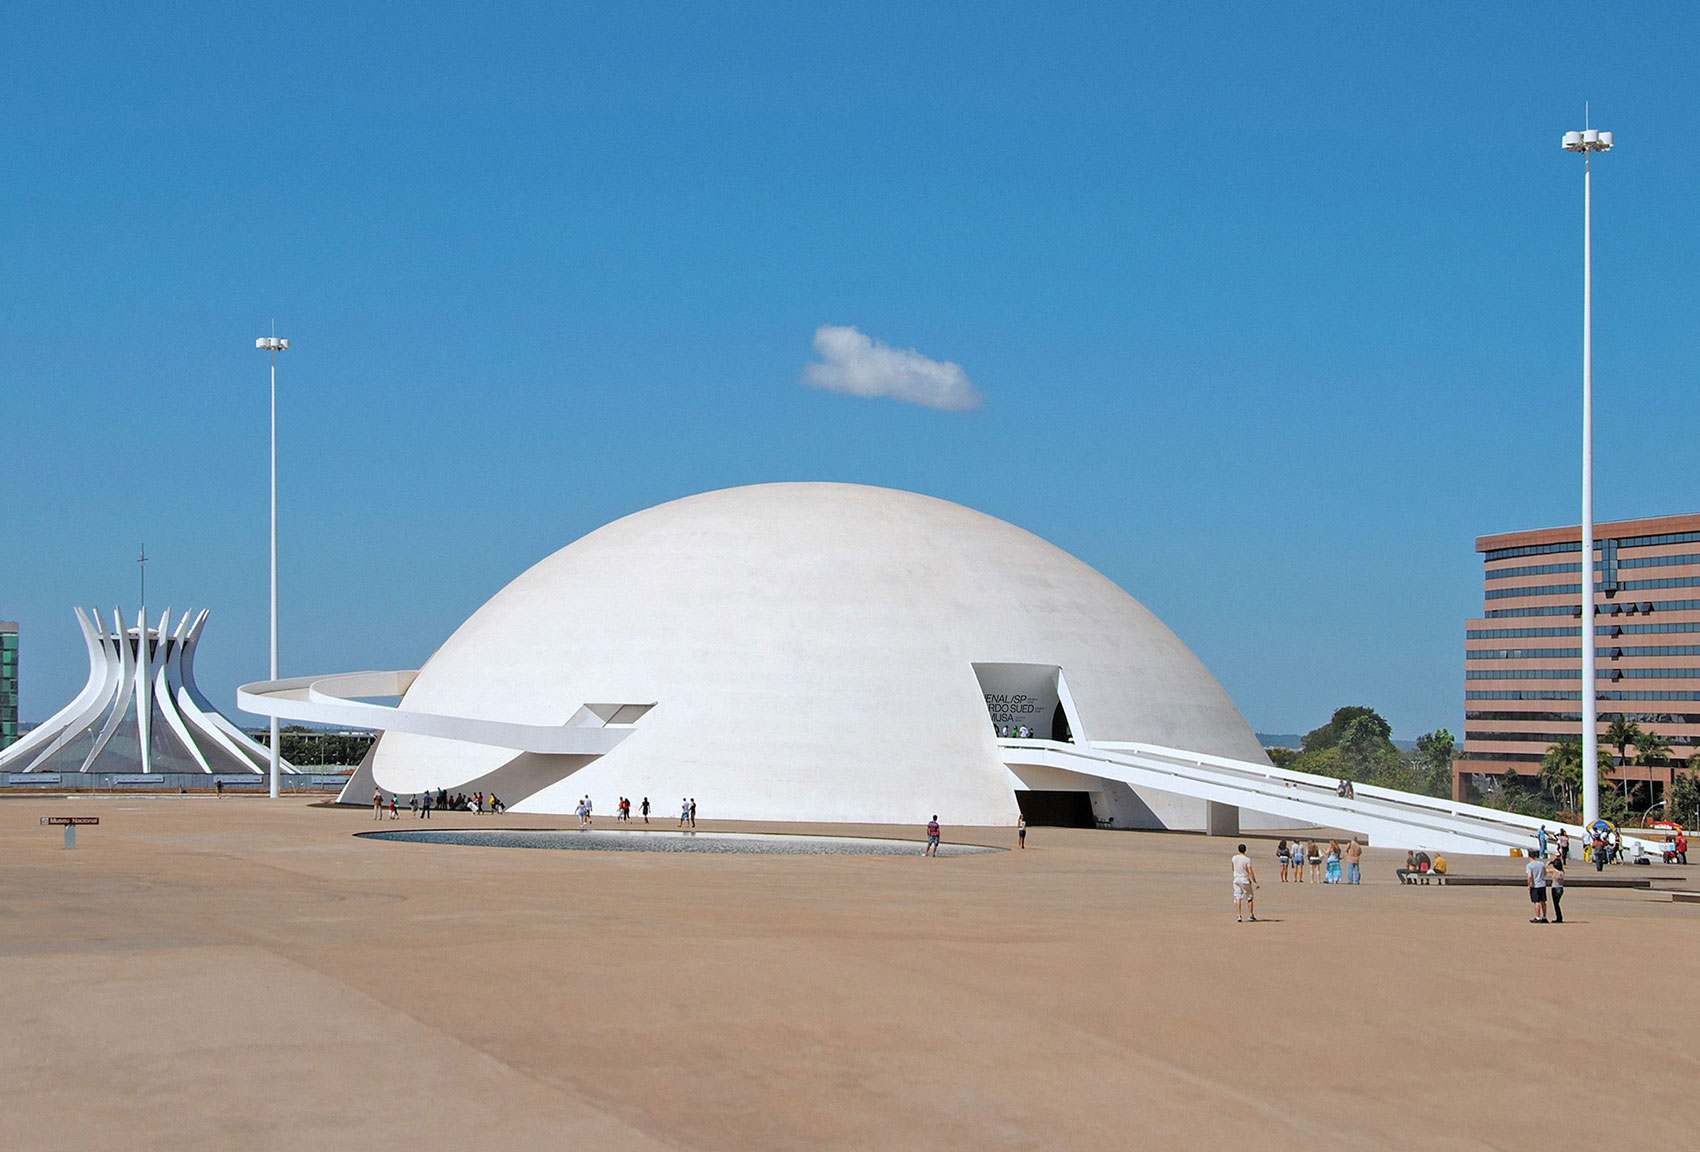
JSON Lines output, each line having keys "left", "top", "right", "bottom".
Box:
{"left": 372, "top": 484, "right": 1267, "bottom": 824}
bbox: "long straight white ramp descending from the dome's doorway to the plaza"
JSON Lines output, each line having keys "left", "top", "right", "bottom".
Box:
{"left": 998, "top": 739, "right": 1586, "bottom": 856}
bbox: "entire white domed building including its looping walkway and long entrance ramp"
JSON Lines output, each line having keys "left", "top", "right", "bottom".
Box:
{"left": 246, "top": 484, "right": 1583, "bottom": 855}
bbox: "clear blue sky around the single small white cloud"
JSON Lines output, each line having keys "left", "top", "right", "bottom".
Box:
{"left": 0, "top": 3, "right": 1700, "bottom": 736}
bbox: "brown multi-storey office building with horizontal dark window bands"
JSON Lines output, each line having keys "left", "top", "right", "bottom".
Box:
{"left": 1452, "top": 515, "right": 1700, "bottom": 807}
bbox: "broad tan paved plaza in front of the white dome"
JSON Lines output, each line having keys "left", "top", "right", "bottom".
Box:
{"left": 0, "top": 795, "right": 1700, "bottom": 1152}
